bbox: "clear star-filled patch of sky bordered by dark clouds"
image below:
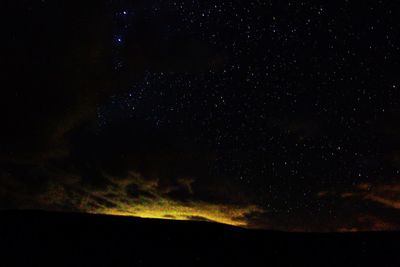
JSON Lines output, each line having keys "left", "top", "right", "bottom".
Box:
{"left": 95, "top": 1, "right": 399, "bottom": 221}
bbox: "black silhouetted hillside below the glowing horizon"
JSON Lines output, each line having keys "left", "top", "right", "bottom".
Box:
{"left": 0, "top": 211, "right": 400, "bottom": 266}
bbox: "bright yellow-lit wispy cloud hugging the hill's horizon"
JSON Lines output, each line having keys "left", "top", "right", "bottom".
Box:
{"left": 91, "top": 173, "right": 261, "bottom": 226}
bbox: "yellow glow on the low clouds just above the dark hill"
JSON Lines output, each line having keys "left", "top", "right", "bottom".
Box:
{"left": 42, "top": 175, "right": 265, "bottom": 227}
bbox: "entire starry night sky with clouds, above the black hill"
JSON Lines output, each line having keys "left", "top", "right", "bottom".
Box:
{"left": 0, "top": 0, "right": 400, "bottom": 231}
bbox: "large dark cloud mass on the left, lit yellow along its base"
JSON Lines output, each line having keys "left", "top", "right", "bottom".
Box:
{"left": 0, "top": 0, "right": 259, "bottom": 230}
